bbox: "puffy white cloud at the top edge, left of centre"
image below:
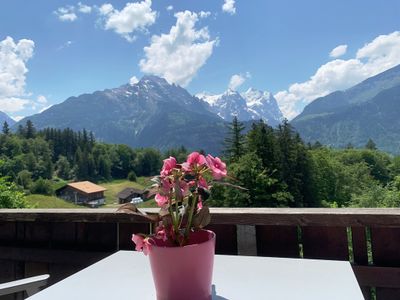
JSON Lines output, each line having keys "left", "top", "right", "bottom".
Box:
{"left": 99, "top": 0, "right": 157, "bottom": 42}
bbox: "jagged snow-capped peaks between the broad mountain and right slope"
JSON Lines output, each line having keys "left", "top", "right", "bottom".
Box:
{"left": 196, "top": 88, "right": 283, "bottom": 126}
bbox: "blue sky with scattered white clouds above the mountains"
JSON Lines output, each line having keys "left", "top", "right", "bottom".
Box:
{"left": 0, "top": 0, "right": 400, "bottom": 118}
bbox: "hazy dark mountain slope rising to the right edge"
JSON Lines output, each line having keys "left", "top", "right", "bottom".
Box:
{"left": 291, "top": 65, "right": 400, "bottom": 154}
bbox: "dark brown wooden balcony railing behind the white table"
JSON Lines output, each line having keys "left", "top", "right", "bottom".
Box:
{"left": 0, "top": 208, "right": 400, "bottom": 300}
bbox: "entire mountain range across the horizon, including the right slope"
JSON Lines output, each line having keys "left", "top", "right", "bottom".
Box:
{"left": 9, "top": 65, "right": 400, "bottom": 154}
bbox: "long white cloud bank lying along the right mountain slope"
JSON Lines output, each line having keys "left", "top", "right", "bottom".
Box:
{"left": 275, "top": 31, "right": 400, "bottom": 119}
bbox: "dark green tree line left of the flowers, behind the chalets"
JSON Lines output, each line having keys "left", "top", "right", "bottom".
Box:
{"left": 0, "top": 120, "right": 187, "bottom": 199}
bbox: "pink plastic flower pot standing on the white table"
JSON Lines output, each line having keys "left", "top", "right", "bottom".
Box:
{"left": 149, "top": 230, "right": 215, "bottom": 300}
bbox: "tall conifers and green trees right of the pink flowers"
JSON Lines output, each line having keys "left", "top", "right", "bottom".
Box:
{"left": 211, "top": 118, "right": 400, "bottom": 207}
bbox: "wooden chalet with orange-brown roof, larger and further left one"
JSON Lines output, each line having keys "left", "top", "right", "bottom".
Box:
{"left": 56, "top": 181, "right": 107, "bottom": 207}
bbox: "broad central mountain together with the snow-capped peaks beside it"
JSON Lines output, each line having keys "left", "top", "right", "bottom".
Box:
{"left": 14, "top": 76, "right": 282, "bottom": 153}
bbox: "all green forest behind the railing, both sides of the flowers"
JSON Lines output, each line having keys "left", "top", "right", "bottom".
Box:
{"left": 0, "top": 118, "right": 400, "bottom": 207}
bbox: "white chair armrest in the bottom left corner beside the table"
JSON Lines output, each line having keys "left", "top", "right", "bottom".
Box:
{"left": 0, "top": 274, "right": 50, "bottom": 297}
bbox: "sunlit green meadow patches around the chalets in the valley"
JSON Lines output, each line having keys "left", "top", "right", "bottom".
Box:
{"left": 26, "top": 177, "right": 157, "bottom": 208}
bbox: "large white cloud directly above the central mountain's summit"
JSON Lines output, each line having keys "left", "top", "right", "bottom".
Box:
{"left": 139, "top": 11, "right": 217, "bottom": 86}
